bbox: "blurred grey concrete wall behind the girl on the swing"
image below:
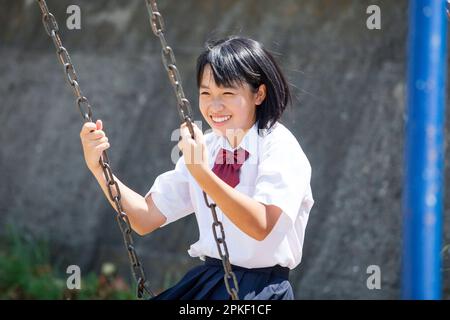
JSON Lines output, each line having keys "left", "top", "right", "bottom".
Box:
{"left": 0, "top": 0, "right": 450, "bottom": 299}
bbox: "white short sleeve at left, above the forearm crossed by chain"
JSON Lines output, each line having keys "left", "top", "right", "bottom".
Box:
{"left": 145, "top": 157, "right": 194, "bottom": 226}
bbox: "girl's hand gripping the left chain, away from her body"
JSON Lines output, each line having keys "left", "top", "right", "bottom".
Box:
{"left": 80, "top": 120, "right": 109, "bottom": 172}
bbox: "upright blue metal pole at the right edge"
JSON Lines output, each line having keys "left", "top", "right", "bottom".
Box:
{"left": 402, "top": 0, "right": 447, "bottom": 299}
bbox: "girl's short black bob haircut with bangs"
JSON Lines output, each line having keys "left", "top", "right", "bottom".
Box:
{"left": 197, "top": 36, "right": 291, "bottom": 130}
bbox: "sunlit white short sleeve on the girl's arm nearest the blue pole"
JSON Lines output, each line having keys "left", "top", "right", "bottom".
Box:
{"left": 253, "top": 139, "right": 311, "bottom": 223}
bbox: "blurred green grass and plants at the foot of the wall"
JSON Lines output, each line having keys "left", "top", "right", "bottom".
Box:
{"left": 0, "top": 226, "right": 135, "bottom": 300}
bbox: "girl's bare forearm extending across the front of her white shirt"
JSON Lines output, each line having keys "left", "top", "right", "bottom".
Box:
{"left": 191, "top": 168, "right": 272, "bottom": 240}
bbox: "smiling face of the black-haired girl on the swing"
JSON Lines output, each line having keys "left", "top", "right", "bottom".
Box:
{"left": 199, "top": 65, "right": 266, "bottom": 147}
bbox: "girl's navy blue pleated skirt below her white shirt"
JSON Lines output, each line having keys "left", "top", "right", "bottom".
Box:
{"left": 152, "top": 257, "right": 294, "bottom": 300}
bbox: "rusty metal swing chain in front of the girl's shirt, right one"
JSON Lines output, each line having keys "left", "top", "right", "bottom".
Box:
{"left": 145, "top": 0, "right": 239, "bottom": 300}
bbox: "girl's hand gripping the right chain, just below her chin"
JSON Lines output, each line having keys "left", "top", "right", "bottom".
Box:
{"left": 178, "top": 122, "right": 209, "bottom": 170}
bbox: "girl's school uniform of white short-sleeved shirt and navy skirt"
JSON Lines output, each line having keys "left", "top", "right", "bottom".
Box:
{"left": 146, "top": 122, "right": 314, "bottom": 300}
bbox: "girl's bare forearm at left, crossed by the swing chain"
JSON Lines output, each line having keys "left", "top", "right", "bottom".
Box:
{"left": 92, "top": 168, "right": 155, "bottom": 235}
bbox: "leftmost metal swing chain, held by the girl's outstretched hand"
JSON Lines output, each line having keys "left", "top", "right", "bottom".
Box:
{"left": 36, "top": 0, "right": 154, "bottom": 299}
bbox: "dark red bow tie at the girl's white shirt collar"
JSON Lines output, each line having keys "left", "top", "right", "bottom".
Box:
{"left": 212, "top": 148, "right": 249, "bottom": 188}
